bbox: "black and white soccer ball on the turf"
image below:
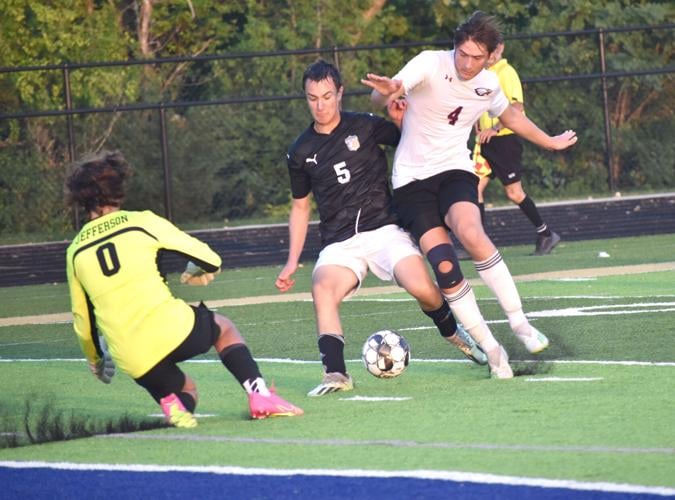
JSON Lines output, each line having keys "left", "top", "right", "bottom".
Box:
{"left": 361, "top": 330, "right": 410, "bottom": 378}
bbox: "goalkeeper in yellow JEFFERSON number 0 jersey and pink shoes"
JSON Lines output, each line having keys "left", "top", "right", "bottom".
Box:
{"left": 66, "top": 151, "right": 302, "bottom": 427}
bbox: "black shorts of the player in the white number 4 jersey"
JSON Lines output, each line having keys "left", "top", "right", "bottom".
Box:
{"left": 394, "top": 170, "right": 478, "bottom": 241}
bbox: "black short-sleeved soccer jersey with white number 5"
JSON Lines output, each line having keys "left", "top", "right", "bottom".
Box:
{"left": 288, "top": 111, "right": 400, "bottom": 246}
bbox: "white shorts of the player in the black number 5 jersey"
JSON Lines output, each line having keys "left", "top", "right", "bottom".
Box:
{"left": 314, "top": 224, "right": 422, "bottom": 290}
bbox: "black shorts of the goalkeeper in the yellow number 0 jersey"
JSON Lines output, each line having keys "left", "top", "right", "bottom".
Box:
{"left": 135, "top": 302, "right": 220, "bottom": 403}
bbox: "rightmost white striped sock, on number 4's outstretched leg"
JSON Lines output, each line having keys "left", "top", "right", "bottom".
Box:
{"left": 474, "top": 251, "right": 530, "bottom": 335}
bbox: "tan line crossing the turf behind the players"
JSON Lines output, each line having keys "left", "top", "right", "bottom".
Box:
{"left": 0, "top": 262, "right": 675, "bottom": 327}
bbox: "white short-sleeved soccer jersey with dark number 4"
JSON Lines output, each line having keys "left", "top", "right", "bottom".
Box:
{"left": 392, "top": 50, "right": 509, "bottom": 189}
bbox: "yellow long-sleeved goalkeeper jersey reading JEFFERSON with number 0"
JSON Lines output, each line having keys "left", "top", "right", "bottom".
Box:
{"left": 66, "top": 210, "right": 221, "bottom": 378}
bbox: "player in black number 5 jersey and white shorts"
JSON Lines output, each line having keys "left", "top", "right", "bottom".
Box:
{"left": 275, "top": 61, "right": 487, "bottom": 396}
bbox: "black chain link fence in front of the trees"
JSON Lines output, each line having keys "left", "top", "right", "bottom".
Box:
{"left": 0, "top": 25, "right": 675, "bottom": 244}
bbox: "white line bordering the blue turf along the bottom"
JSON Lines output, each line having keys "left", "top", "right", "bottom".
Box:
{"left": 0, "top": 461, "right": 675, "bottom": 496}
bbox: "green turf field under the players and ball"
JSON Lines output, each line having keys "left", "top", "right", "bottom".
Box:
{"left": 0, "top": 235, "right": 675, "bottom": 487}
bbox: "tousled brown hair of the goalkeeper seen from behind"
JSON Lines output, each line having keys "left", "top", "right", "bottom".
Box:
{"left": 66, "top": 151, "right": 131, "bottom": 212}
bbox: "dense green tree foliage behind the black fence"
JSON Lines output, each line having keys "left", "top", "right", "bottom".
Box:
{"left": 0, "top": 0, "right": 675, "bottom": 238}
